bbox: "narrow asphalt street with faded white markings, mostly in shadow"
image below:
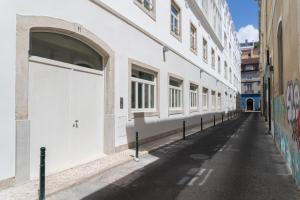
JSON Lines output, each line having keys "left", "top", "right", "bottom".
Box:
{"left": 52, "top": 113, "right": 300, "bottom": 200}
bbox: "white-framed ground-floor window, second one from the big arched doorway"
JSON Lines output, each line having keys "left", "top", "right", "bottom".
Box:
{"left": 169, "top": 77, "right": 182, "bottom": 110}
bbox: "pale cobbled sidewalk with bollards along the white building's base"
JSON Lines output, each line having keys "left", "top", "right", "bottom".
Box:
{"left": 0, "top": 115, "right": 234, "bottom": 200}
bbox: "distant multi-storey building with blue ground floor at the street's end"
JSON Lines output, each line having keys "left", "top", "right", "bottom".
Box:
{"left": 240, "top": 41, "right": 261, "bottom": 111}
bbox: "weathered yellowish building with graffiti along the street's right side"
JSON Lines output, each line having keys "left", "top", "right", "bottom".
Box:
{"left": 259, "top": 0, "right": 300, "bottom": 185}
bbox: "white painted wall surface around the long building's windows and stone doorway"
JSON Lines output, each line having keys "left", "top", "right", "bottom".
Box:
{"left": 0, "top": 0, "right": 240, "bottom": 180}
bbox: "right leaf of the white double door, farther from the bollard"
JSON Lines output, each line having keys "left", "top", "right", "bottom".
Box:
{"left": 69, "top": 70, "right": 103, "bottom": 164}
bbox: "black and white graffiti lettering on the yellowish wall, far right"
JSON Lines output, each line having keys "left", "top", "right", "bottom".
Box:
{"left": 285, "top": 80, "right": 300, "bottom": 149}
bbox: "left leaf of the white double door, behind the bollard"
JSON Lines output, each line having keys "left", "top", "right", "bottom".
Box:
{"left": 28, "top": 62, "right": 71, "bottom": 178}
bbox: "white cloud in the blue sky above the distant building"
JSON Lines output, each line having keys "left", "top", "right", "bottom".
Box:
{"left": 237, "top": 24, "right": 259, "bottom": 43}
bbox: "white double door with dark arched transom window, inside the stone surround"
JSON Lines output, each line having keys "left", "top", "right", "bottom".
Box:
{"left": 28, "top": 31, "right": 104, "bottom": 178}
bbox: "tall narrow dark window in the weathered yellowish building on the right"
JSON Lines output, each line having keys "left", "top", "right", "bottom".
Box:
{"left": 277, "top": 22, "right": 284, "bottom": 94}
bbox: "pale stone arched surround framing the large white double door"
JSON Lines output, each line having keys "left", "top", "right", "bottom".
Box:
{"left": 15, "top": 15, "right": 115, "bottom": 182}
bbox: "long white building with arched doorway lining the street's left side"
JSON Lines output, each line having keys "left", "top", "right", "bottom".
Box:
{"left": 0, "top": 0, "right": 241, "bottom": 183}
